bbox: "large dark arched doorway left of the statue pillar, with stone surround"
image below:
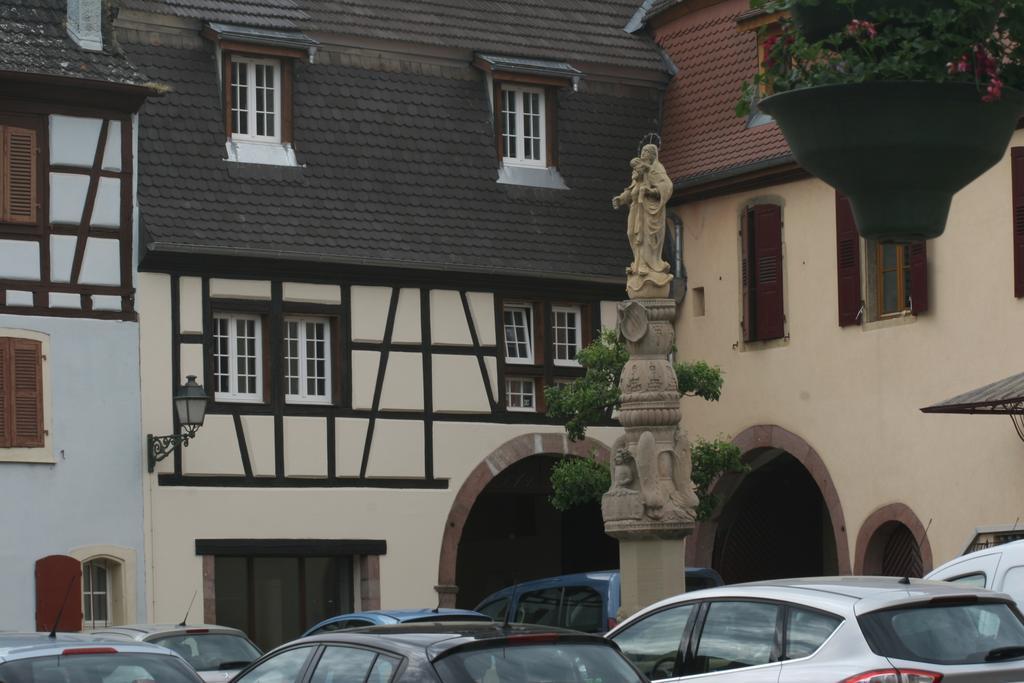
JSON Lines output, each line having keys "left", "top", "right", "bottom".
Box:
{"left": 437, "top": 434, "right": 618, "bottom": 608}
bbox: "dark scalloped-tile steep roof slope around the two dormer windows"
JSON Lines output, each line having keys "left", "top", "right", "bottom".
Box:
{"left": 125, "top": 38, "right": 657, "bottom": 280}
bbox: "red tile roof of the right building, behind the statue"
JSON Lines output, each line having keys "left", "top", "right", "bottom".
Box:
{"left": 653, "top": 0, "right": 790, "bottom": 181}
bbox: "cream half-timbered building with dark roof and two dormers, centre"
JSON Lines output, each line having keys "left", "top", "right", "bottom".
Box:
{"left": 117, "top": 0, "right": 669, "bottom": 645}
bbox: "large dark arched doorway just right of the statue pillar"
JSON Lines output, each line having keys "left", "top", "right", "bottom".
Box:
{"left": 687, "top": 425, "right": 851, "bottom": 583}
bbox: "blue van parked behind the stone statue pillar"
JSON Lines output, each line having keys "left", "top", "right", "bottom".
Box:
{"left": 476, "top": 567, "right": 722, "bottom": 633}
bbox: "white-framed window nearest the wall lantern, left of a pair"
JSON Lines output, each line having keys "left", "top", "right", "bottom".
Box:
{"left": 213, "top": 313, "right": 263, "bottom": 402}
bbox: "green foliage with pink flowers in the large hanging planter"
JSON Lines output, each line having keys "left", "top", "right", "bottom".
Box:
{"left": 736, "top": 0, "right": 1024, "bottom": 116}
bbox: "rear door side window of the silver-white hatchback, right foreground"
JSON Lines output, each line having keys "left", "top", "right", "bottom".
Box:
{"left": 694, "top": 601, "right": 779, "bottom": 674}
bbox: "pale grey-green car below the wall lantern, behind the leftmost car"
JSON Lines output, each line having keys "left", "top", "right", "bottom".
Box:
{"left": 90, "top": 624, "right": 262, "bottom": 683}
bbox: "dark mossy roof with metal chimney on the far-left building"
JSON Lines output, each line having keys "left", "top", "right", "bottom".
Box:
{"left": 0, "top": 0, "right": 148, "bottom": 85}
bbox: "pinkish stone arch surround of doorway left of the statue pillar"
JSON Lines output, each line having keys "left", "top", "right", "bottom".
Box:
{"left": 434, "top": 432, "right": 611, "bottom": 607}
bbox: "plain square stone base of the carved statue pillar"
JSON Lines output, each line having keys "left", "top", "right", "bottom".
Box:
{"left": 616, "top": 539, "right": 686, "bottom": 622}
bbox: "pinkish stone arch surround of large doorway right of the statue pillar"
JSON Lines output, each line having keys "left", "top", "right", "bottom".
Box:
{"left": 686, "top": 425, "right": 852, "bottom": 574}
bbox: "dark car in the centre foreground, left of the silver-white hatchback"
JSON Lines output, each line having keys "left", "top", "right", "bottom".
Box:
{"left": 232, "top": 622, "right": 646, "bottom": 683}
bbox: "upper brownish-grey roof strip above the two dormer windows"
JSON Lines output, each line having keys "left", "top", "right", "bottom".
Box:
{"left": 124, "top": 0, "right": 666, "bottom": 73}
